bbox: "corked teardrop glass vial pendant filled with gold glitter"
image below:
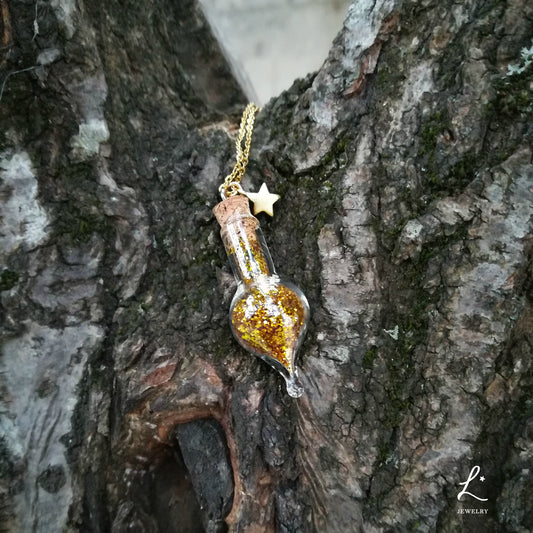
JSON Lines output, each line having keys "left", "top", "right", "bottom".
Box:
{"left": 213, "top": 195, "right": 309, "bottom": 398}
